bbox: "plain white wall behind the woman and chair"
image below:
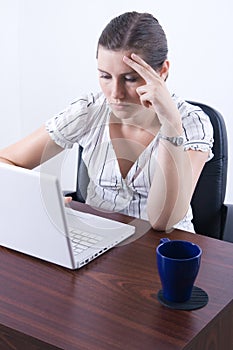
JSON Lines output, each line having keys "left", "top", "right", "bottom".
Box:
{"left": 0, "top": 0, "right": 233, "bottom": 202}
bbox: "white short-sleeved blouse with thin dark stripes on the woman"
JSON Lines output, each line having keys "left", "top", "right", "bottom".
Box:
{"left": 46, "top": 93, "right": 213, "bottom": 231}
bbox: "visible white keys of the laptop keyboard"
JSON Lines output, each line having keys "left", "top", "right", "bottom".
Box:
{"left": 69, "top": 227, "right": 103, "bottom": 254}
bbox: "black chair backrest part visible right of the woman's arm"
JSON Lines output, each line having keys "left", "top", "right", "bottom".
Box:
{"left": 188, "top": 101, "right": 228, "bottom": 239}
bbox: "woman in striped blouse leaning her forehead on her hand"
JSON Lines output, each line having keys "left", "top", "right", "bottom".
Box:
{"left": 0, "top": 12, "right": 213, "bottom": 231}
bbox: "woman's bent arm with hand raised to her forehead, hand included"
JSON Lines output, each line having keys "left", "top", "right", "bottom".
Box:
{"left": 124, "top": 54, "right": 208, "bottom": 231}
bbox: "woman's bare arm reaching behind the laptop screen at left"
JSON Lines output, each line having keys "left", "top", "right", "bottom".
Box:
{"left": 0, "top": 126, "right": 63, "bottom": 169}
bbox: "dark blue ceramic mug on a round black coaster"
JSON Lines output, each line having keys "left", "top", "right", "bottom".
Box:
{"left": 156, "top": 238, "right": 202, "bottom": 303}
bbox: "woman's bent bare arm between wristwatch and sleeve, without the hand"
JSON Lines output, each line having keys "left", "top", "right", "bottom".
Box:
{"left": 147, "top": 144, "right": 208, "bottom": 231}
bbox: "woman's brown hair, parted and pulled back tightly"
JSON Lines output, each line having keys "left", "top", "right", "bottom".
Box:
{"left": 97, "top": 11, "right": 168, "bottom": 69}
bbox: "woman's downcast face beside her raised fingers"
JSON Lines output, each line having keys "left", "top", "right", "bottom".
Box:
{"left": 97, "top": 46, "right": 145, "bottom": 118}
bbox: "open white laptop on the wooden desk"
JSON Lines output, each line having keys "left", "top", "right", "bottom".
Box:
{"left": 0, "top": 163, "right": 135, "bottom": 269}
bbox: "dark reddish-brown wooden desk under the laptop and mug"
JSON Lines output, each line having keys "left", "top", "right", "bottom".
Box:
{"left": 0, "top": 204, "right": 233, "bottom": 350}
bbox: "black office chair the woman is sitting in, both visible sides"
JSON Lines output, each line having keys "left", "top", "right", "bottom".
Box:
{"left": 66, "top": 101, "right": 233, "bottom": 242}
